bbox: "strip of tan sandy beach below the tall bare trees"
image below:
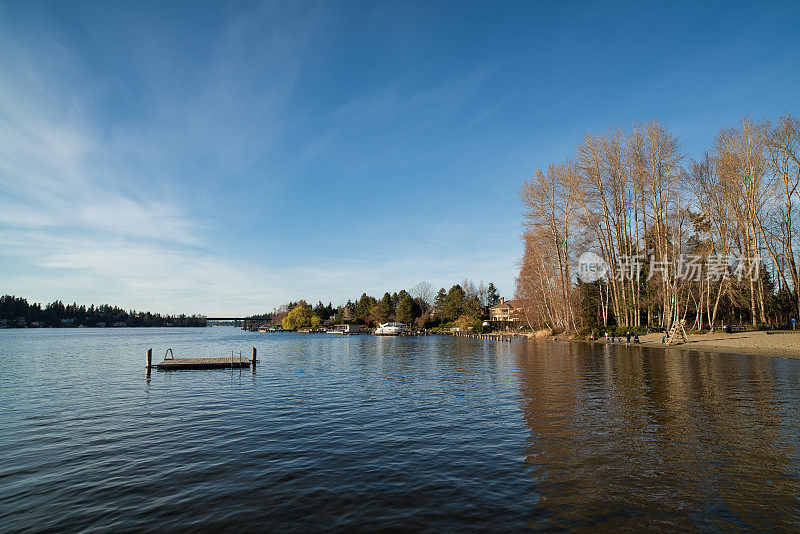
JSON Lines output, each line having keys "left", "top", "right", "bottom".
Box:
{"left": 529, "top": 330, "right": 800, "bottom": 358}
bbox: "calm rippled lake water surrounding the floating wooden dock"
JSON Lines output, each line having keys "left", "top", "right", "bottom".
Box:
{"left": 0, "top": 328, "right": 800, "bottom": 532}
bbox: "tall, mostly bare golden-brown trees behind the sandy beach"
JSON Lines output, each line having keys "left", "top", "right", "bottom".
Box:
{"left": 516, "top": 114, "right": 800, "bottom": 335}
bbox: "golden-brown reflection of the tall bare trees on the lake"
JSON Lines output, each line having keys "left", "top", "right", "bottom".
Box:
{"left": 518, "top": 344, "right": 800, "bottom": 530}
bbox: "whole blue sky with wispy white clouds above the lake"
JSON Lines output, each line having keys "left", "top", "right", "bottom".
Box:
{"left": 0, "top": 1, "right": 800, "bottom": 315}
